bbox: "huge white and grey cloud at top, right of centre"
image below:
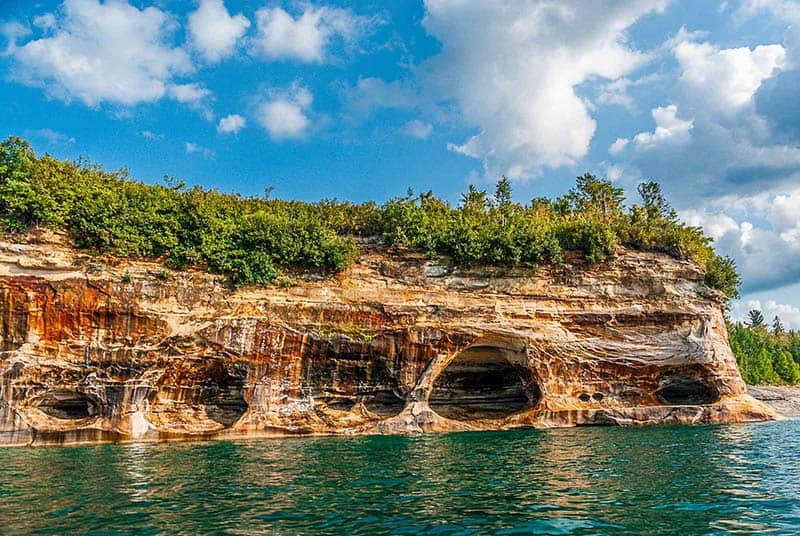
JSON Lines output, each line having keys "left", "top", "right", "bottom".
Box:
{"left": 423, "top": 0, "right": 667, "bottom": 178}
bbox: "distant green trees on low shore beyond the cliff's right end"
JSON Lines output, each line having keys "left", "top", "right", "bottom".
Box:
{"left": 728, "top": 309, "right": 800, "bottom": 385}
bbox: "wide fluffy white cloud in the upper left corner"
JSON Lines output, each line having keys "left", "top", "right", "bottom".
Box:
{"left": 9, "top": 0, "right": 192, "bottom": 106}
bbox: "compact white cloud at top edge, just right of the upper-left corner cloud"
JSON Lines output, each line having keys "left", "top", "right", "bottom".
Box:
{"left": 189, "top": 0, "right": 250, "bottom": 63}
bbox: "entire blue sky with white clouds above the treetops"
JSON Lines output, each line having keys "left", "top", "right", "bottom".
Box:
{"left": 0, "top": 0, "right": 800, "bottom": 328}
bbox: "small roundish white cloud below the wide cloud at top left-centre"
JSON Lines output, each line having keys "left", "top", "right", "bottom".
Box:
{"left": 258, "top": 84, "right": 313, "bottom": 141}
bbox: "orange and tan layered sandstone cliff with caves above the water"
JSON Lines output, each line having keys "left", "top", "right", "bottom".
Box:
{"left": 0, "top": 243, "right": 776, "bottom": 445}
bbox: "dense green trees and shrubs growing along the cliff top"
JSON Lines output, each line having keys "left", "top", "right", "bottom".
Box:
{"left": 0, "top": 137, "right": 740, "bottom": 297}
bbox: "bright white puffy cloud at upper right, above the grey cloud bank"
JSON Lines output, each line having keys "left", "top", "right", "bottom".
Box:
{"left": 674, "top": 41, "right": 786, "bottom": 112}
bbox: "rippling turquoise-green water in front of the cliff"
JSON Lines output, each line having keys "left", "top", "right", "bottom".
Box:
{"left": 0, "top": 421, "right": 800, "bottom": 535}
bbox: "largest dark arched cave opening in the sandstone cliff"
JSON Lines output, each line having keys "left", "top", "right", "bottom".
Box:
{"left": 428, "top": 346, "right": 541, "bottom": 420}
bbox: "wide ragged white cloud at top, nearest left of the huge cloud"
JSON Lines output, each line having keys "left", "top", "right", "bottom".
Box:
{"left": 253, "top": 6, "right": 369, "bottom": 63}
